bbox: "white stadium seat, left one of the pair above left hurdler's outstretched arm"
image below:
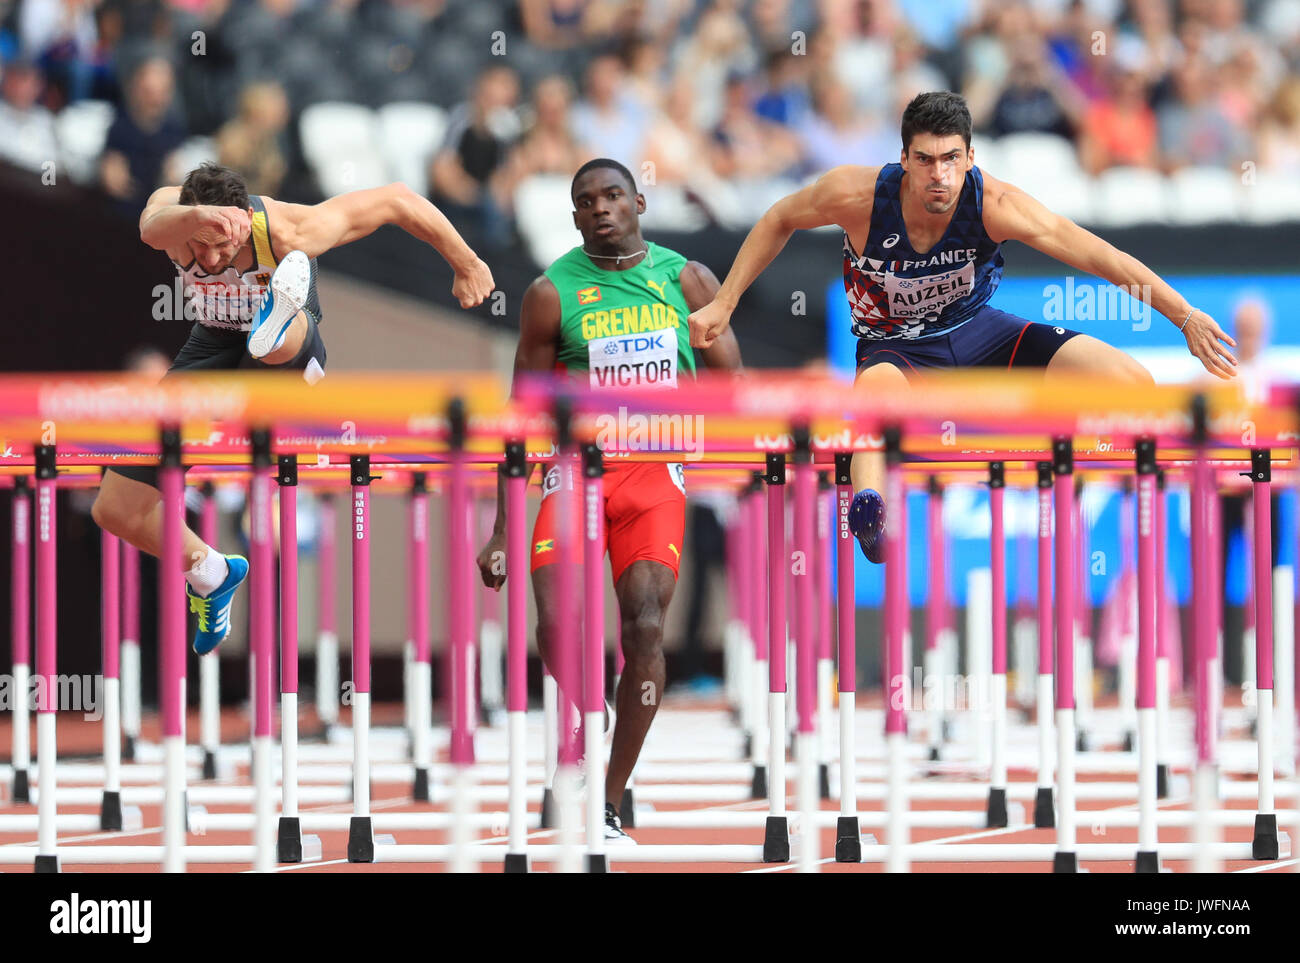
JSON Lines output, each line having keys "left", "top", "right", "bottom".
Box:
{"left": 298, "top": 101, "right": 390, "bottom": 198}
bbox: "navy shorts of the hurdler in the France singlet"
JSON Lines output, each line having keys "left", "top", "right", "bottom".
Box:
{"left": 858, "top": 305, "right": 1079, "bottom": 374}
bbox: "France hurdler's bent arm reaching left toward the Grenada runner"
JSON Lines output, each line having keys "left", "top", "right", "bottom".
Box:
{"left": 689, "top": 166, "right": 875, "bottom": 348}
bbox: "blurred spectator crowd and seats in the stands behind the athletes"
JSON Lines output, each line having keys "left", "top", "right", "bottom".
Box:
{"left": 0, "top": 0, "right": 1300, "bottom": 248}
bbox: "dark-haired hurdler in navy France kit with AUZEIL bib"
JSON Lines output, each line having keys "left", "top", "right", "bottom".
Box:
{"left": 689, "top": 91, "right": 1236, "bottom": 563}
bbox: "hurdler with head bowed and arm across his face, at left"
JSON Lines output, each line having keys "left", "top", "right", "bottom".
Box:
{"left": 92, "top": 164, "right": 493, "bottom": 654}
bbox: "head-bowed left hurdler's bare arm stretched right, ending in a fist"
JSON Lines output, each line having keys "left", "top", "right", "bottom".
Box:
{"left": 267, "top": 183, "right": 493, "bottom": 308}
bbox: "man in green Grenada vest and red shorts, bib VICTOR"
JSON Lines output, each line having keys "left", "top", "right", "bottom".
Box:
{"left": 478, "top": 157, "right": 741, "bottom": 842}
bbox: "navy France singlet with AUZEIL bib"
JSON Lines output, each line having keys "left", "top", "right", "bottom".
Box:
{"left": 844, "top": 164, "right": 1002, "bottom": 340}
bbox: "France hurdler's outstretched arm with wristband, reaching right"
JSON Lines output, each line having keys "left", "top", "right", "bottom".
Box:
{"left": 984, "top": 174, "right": 1236, "bottom": 379}
